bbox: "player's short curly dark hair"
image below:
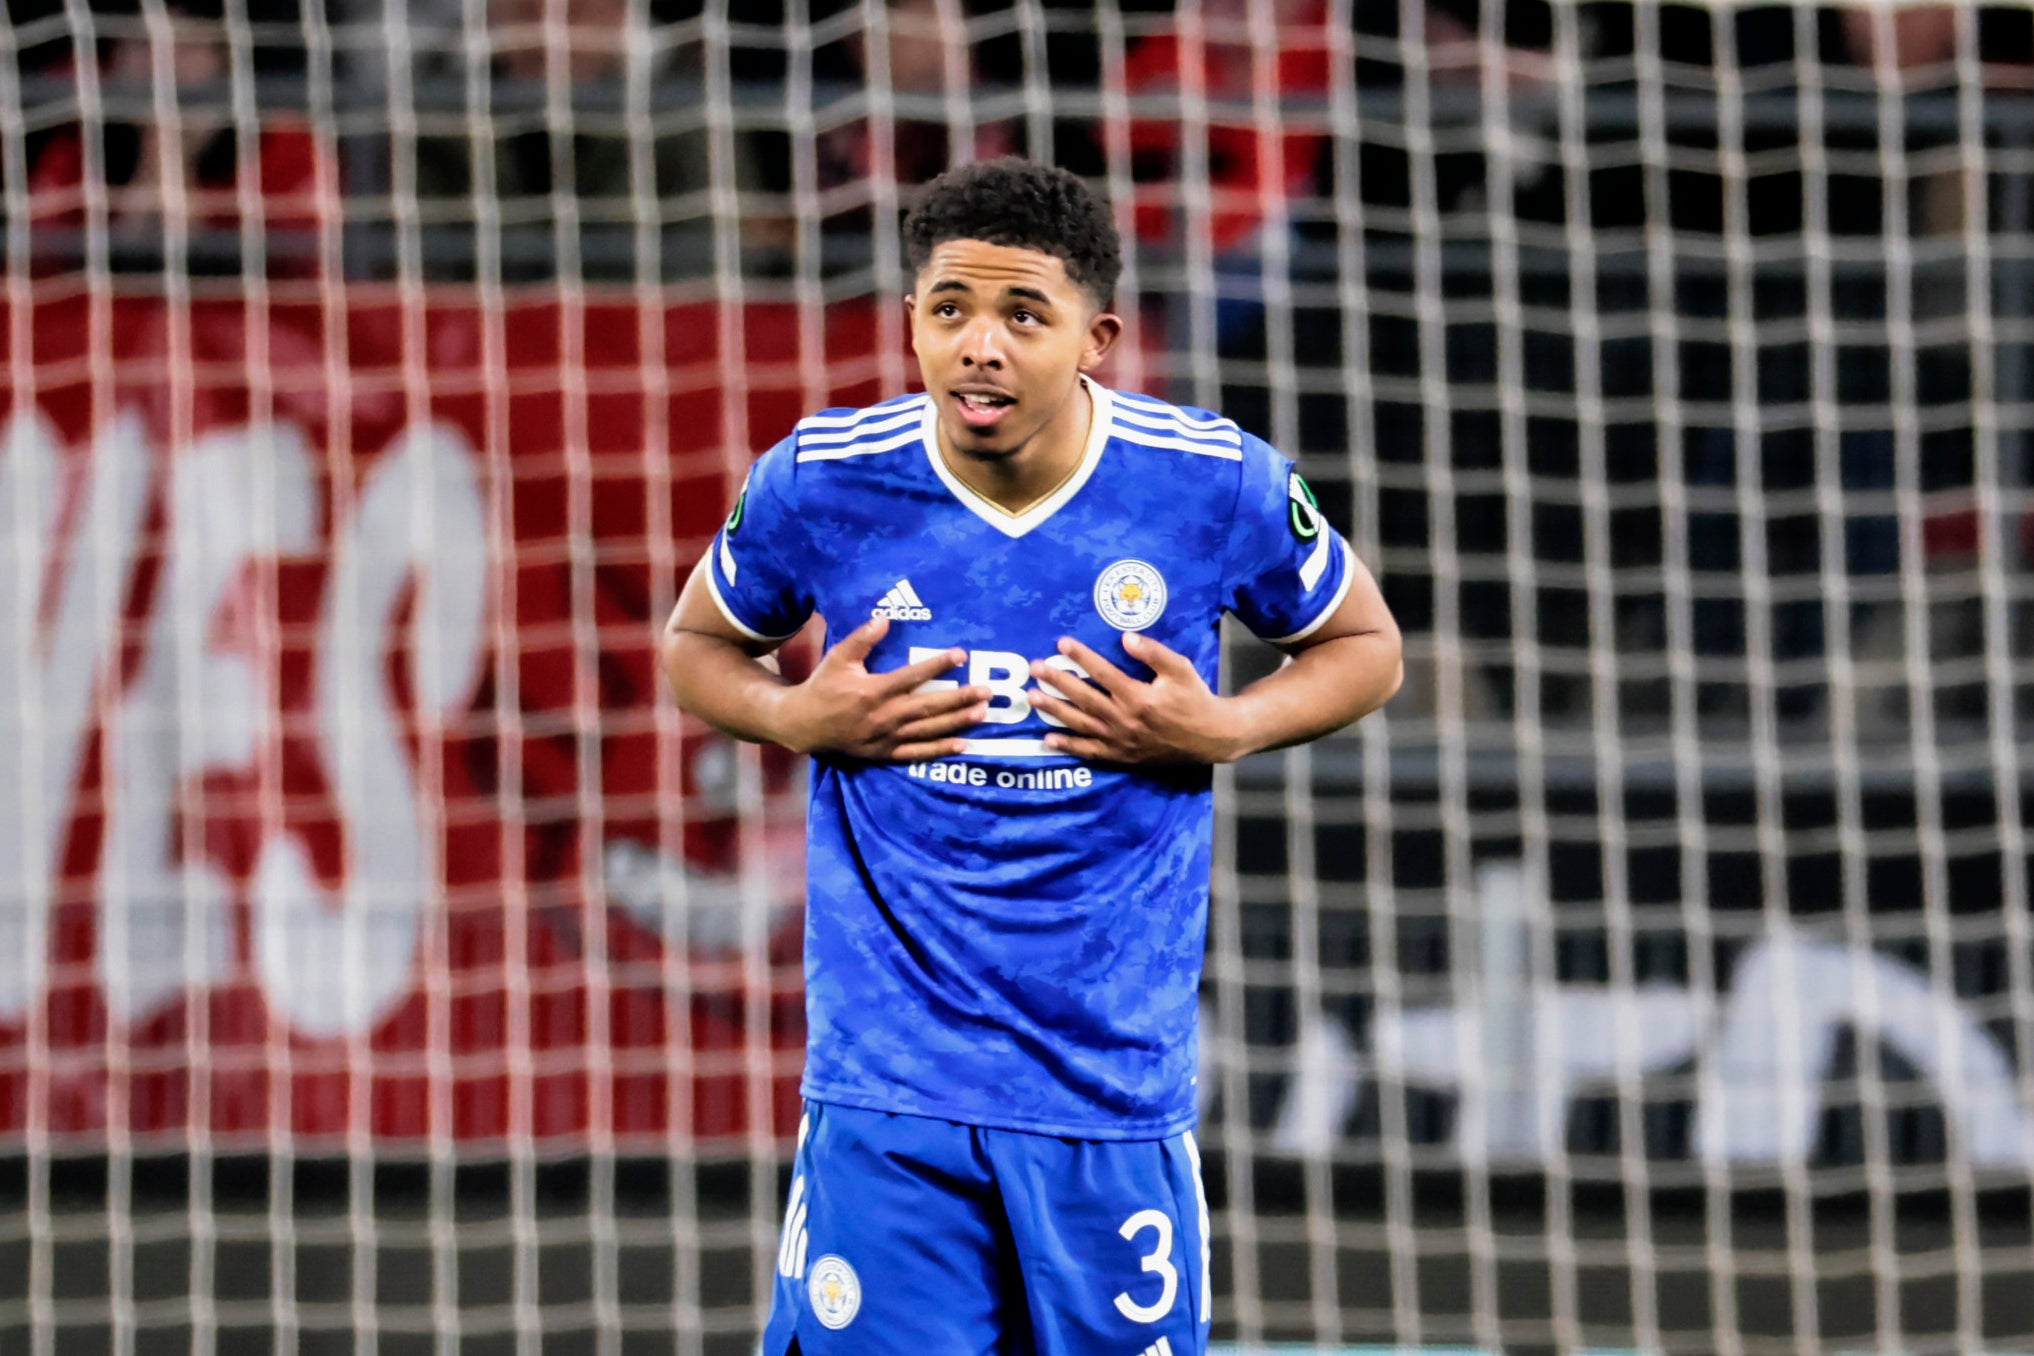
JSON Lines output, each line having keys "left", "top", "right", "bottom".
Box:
{"left": 903, "top": 155, "right": 1123, "bottom": 307}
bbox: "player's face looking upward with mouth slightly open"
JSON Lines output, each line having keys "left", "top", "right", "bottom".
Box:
{"left": 905, "top": 240, "right": 1123, "bottom": 461}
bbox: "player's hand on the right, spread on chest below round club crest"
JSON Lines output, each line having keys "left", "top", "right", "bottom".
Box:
{"left": 1031, "top": 630, "right": 1241, "bottom": 762}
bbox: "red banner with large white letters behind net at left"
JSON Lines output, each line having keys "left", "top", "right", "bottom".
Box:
{"left": 0, "top": 289, "right": 903, "bottom": 1151}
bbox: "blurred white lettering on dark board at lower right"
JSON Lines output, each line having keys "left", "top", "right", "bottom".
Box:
{"left": 1244, "top": 864, "right": 2034, "bottom": 1171}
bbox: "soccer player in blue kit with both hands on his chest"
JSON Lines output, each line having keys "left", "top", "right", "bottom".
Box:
{"left": 663, "top": 159, "right": 1399, "bottom": 1356}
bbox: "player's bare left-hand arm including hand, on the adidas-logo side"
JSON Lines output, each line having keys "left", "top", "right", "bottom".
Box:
{"left": 661, "top": 561, "right": 989, "bottom": 762}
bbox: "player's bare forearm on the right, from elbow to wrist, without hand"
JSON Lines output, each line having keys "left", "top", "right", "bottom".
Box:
{"left": 1229, "top": 628, "right": 1405, "bottom": 758}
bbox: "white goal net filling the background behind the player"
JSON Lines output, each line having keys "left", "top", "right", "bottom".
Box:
{"left": 0, "top": 0, "right": 2034, "bottom": 1356}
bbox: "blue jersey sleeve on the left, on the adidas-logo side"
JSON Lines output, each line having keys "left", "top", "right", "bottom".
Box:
{"left": 706, "top": 439, "right": 814, "bottom": 640}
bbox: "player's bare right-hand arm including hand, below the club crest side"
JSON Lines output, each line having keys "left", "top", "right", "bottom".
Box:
{"left": 1031, "top": 553, "right": 1405, "bottom": 762}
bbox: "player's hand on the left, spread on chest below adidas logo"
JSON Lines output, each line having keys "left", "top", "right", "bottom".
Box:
{"left": 775, "top": 616, "right": 991, "bottom": 762}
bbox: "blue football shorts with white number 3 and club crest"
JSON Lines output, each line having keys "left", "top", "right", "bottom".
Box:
{"left": 763, "top": 1102, "right": 1210, "bottom": 1356}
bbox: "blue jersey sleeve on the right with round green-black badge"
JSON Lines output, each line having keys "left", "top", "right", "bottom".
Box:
{"left": 1222, "top": 435, "right": 1353, "bottom": 644}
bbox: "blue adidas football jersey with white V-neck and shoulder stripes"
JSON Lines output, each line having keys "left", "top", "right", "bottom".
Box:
{"left": 708, "top": 382, "right": 1353, "bottom": 1138}
